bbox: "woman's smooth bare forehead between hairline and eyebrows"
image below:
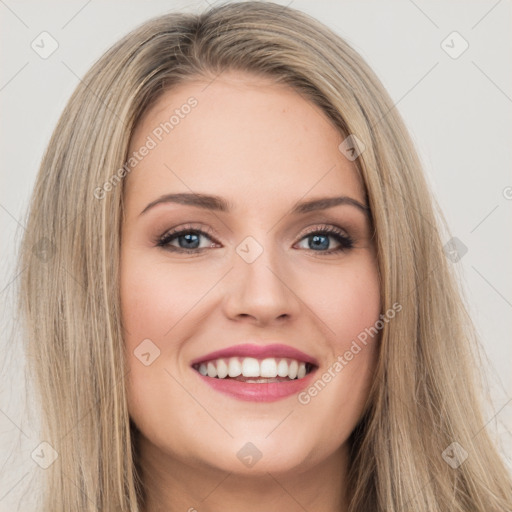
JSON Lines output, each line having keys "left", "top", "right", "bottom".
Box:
{"left": 125, "top": 72, "right": 364, "bottom": 214}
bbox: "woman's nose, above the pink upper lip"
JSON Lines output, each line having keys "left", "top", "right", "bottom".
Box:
{"left": 224, "top": 239, "right": 301, "bottom": 325}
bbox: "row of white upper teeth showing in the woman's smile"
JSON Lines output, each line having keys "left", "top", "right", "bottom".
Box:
{"left": 196, "top": 357, "right": 307, "bottom": 382}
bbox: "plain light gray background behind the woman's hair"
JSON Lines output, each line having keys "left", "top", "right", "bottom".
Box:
{"left": 0, "top": 0, "right": 512, "bottom": 511}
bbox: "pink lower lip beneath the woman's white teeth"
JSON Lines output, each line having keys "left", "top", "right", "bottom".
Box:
{"left": 194, "top": 369, "right": 316, "bottom": 402}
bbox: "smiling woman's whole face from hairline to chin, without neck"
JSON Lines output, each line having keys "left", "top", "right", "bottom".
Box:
{"left": 121, "top": 73, "right": 380, "bottom": 474}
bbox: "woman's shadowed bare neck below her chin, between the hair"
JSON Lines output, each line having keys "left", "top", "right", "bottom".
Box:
{"left": 138, "top": 436, "right": 349, "bottom": 512}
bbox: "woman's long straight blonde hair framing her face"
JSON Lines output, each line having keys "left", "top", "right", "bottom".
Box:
{"left": 19, "top": 2, "right": 512, "bottom": 512}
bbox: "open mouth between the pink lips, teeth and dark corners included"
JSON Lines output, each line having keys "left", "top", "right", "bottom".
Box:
{"left": 192, "top": 357, "right": 316, "bottom": 384}
